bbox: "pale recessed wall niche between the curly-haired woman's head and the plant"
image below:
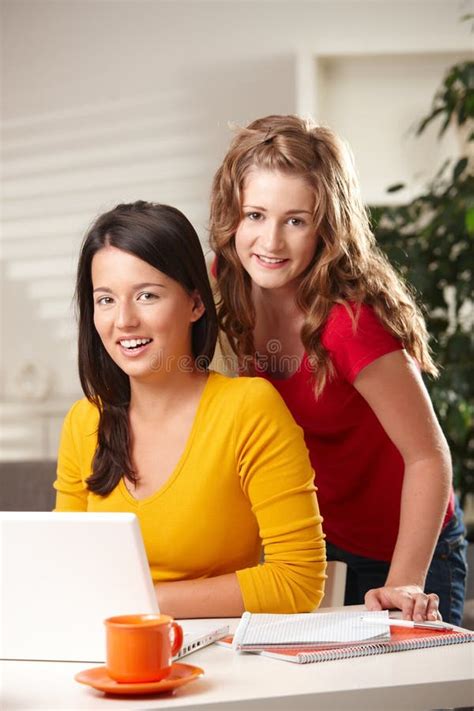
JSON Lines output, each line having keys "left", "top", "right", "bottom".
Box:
{"left": 315, "top": 50, "right": 466, "bottom": 205}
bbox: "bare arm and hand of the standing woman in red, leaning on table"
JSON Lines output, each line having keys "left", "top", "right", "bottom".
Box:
{"left": 354, "top": 351, "right": 452, "bottom": 620}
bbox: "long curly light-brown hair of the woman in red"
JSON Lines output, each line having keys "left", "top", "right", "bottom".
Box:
{"left": 210, "top": 115, "right": 438, "bottom": 395}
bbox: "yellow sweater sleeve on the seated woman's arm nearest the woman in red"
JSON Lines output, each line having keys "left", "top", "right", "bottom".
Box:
{"left": 235, "top": 378, "right": 326, "bottom": 613}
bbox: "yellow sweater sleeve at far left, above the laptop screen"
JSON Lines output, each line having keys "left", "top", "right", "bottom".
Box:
{"left": 53, "top": 400, "right": 97, "bottom": 511}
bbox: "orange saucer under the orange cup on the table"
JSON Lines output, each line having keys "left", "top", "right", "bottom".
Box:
{"left": 74, "top": 662, "right": 204, "bottom": 694}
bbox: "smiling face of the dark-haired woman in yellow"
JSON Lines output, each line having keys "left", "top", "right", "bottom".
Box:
{"left": 92, "top": 246, "right": 204, "bottom": 380}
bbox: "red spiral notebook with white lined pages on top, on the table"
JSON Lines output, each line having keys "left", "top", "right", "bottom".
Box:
{"left": 218, "top": 611, "right": 474, "bottom": 664}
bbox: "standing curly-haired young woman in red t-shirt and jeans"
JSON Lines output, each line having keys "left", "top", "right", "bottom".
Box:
{"left": 210, "top": 116, "right": 466, "bottom": 623}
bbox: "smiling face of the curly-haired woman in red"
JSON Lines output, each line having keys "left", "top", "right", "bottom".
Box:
{"left": 235, "top": 168, "right": 316, "bottom": 289}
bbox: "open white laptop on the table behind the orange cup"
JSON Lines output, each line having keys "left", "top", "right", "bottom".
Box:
{"left": 0, "top": 512, "right": 228, "bottom": 662}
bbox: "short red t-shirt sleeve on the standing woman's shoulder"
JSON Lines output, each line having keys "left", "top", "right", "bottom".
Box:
{"left": 322, "top": 304, "right": 403, "bottom": 384}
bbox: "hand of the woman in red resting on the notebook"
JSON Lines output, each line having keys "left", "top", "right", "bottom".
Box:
{"left": 365, "top": 585, "right": 441, "bottom": 622}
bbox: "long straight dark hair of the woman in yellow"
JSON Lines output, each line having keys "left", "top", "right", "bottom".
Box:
{"left": 76, "top": 201, "right": 218, "bottom": 496}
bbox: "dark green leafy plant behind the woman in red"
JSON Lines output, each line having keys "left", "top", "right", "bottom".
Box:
{"left": 371, "top": 62, "right": 474, "bottom": 524}
